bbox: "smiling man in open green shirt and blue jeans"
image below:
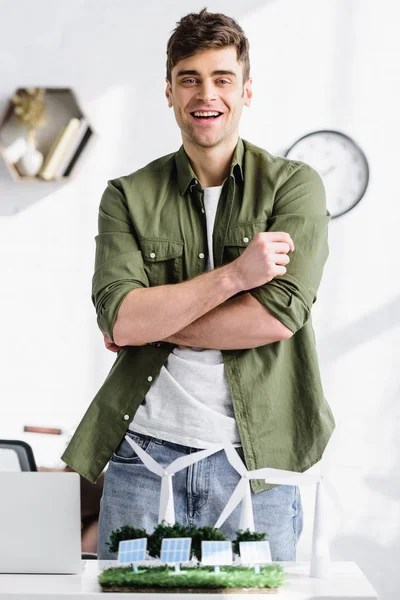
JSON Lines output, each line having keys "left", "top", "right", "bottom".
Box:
{"left": 63, "top": 9, "right": 334, "bottom": 560}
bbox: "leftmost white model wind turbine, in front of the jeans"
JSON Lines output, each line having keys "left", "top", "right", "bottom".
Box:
{"left": 125, "top": 435, "right": 224, "bottom": 525}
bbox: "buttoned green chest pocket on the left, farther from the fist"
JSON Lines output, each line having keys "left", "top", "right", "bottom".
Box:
{"left": 140, "top": 238, "right": 183, "bottom": 286}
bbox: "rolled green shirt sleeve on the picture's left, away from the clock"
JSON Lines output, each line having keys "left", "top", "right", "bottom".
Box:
{"left": 92, "top": 180, "right": 149, "bottom": 341}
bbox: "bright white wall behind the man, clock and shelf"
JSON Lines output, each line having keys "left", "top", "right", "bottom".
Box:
{"left": 0, "top": 0, "right": 400, "bottom": 600}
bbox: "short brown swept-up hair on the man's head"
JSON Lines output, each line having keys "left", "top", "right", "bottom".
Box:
{"left": 167, "top": 8, "right": 250, "bottom": 83}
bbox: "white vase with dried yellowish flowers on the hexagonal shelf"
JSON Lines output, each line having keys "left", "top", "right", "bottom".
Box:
{"left": 11, "top": 88, "right": 46, "bottom": 176}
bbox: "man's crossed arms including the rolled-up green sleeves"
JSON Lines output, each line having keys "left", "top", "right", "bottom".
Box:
{"left": 92, "top": 165, "right": 329, "bottom": 350}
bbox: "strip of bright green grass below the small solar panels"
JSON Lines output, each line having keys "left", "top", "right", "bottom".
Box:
{"left": 99, "top": 564, "right": 285, "bottom": 591}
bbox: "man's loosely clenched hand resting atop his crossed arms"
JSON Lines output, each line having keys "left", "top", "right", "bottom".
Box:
{"left": 231, "top": 231, "right": 294, "bottom": 290}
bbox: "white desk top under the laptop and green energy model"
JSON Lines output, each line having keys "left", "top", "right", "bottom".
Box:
{"left": 0, "top": 560, "right": 378, "bottom": 600}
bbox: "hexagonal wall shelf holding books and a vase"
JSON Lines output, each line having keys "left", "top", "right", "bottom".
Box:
{"left": 0, "top": 88, "right": 93, "bottom": 181}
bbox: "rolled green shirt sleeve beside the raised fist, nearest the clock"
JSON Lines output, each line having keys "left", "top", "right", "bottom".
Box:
{"left": 250, "top": 162, "right": 330, "bottom": 333}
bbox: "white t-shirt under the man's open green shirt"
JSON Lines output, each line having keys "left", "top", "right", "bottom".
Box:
{"left": 129, "top": 186, "right": 240, "bottom": 448}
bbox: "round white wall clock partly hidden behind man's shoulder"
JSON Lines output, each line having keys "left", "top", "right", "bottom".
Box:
{"left": 286, "top": 131, "right": 369, "bottom": 218}
